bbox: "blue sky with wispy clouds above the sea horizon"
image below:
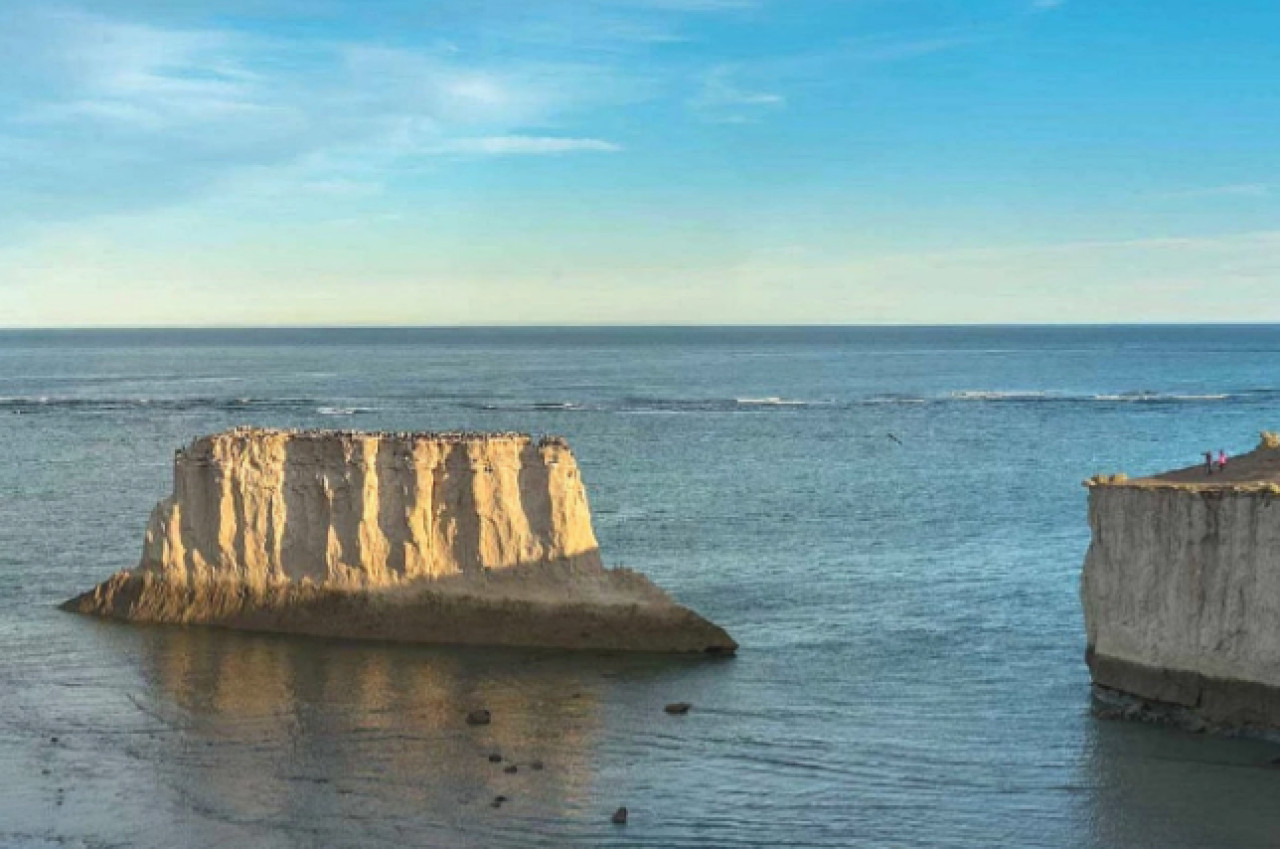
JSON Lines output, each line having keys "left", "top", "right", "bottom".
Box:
{"left": 0, "top": 0, "right": 1280, "bottom": 327}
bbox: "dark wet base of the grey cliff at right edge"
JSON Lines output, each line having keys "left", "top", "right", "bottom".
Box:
{"left": 1085, "top": 649, "right": 1280, "bottom": 735}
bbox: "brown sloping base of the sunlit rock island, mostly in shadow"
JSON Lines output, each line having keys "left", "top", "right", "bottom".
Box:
{"left": 61, "top": 565, "right": 737, "bottom": 654}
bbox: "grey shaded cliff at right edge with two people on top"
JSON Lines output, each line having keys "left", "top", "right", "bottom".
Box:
{"left": 1082, "top": 434, "right": 1280, "bottom": 729}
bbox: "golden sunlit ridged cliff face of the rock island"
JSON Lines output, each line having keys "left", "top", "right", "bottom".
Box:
{"left": 142, "top": 430, "right": 599, "bottom": 588}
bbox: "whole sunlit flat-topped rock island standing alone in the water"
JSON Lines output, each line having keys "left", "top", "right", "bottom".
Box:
{"left": 63, "top": 428, "right": 736, "bottom": 653}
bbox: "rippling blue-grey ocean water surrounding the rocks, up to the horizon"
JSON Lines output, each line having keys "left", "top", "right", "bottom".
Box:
{"left": 0, "top": 327, "right": 1280, "bottom": 849}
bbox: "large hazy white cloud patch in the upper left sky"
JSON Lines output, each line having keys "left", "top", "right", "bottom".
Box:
{"left": 0, "top": 4, "right": 636, "bottom": 229}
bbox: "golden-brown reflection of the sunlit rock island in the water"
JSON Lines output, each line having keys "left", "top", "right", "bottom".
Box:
{"left": 142, "top": 629, "right": 609, "bottom": 845}
